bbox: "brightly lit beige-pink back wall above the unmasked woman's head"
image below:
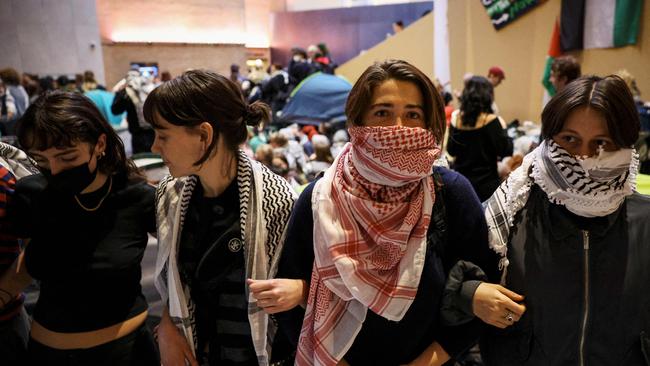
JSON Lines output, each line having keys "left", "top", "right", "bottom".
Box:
{"left": 96, "top": 0, "right": 278, "bottom": 86}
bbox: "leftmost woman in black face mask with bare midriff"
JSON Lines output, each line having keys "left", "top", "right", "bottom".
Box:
{"left": 0, "top": 92, "right": 159, "bottom": 365}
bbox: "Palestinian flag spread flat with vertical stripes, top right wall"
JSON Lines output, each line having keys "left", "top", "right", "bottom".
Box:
{"left": 560, "top": 0, "right": 643, "bottom": 51}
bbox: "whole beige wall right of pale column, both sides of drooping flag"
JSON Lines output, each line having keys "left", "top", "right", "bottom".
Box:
{"left": 448, "top": 0, "right": 650, "bottom": 122}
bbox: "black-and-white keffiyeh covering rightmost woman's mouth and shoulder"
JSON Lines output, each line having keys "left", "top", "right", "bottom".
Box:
{"left": 483, "top": 139, "right": 639, "bottom": 282}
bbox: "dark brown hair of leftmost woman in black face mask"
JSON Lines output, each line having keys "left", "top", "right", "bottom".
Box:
{"left": 16, "top": 91, "right": 139, "bottom": 177}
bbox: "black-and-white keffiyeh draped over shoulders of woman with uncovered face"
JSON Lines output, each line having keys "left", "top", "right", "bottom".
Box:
{"left": 154, "top": 150, "right": 296, "bottom": 365}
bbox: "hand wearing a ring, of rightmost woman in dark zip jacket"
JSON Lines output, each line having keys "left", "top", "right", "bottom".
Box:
{"left": 472, "top": 282, "right": 526, "bottom": 329}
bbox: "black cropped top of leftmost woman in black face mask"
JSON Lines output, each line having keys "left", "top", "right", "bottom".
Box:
{"left": 9, "top": 174, "right": 156, "bottom": 332}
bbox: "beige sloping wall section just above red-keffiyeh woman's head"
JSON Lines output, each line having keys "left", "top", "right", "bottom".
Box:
{"left": 336, "top": 13, "right": 433, "bottom": 84}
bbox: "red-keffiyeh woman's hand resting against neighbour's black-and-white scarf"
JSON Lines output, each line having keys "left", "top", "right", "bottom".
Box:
{"left": 246, "top": 278, "right": 307, "bottom": 314}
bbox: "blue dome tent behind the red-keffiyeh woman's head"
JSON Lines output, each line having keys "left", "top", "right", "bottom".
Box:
{"left": 280, "top": 72, "right": 352, "bottom": 125}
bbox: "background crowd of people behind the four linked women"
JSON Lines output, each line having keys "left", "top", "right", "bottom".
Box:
{"left": 0, "top": 43, "right": 650, "bottom": 194}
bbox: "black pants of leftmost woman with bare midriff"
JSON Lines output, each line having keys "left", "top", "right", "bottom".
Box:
{"left": 27, "top": 325, "right": 160, "bottom": 366}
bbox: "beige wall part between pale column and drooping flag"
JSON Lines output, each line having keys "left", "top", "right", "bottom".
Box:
{"left": 448, "top": 0, "right": 560, "bottom": 121}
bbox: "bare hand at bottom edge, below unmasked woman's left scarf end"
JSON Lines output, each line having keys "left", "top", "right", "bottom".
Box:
{"left": 158, "top": 309, "right": 199, "bottom": 366}
